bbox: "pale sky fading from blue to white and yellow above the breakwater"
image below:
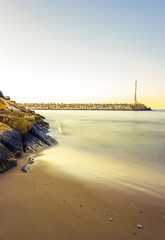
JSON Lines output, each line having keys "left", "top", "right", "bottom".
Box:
{"left": 0, "top": 0, "right": 165, "bottom": 109}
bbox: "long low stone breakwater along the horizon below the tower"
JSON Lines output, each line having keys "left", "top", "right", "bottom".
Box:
{"left": 19, "top": 103, "right": 151, "bottom": 111}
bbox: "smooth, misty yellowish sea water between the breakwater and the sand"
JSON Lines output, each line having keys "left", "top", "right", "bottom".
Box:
{"left": 36, "top": 110, "right": 165, "bottom": 199}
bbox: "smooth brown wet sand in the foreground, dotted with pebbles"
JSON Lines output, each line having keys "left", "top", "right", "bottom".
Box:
{"left": 0, "top": 155, "right": 165, "bottom": 240}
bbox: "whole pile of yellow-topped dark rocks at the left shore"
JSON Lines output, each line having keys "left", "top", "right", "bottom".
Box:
{"left": 0, "top": 91, "right": 57, "bottom": 173}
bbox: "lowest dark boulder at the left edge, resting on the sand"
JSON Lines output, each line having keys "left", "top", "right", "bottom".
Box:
{"left": 0, "top": 143, "right": 17, "bottom": 173}
